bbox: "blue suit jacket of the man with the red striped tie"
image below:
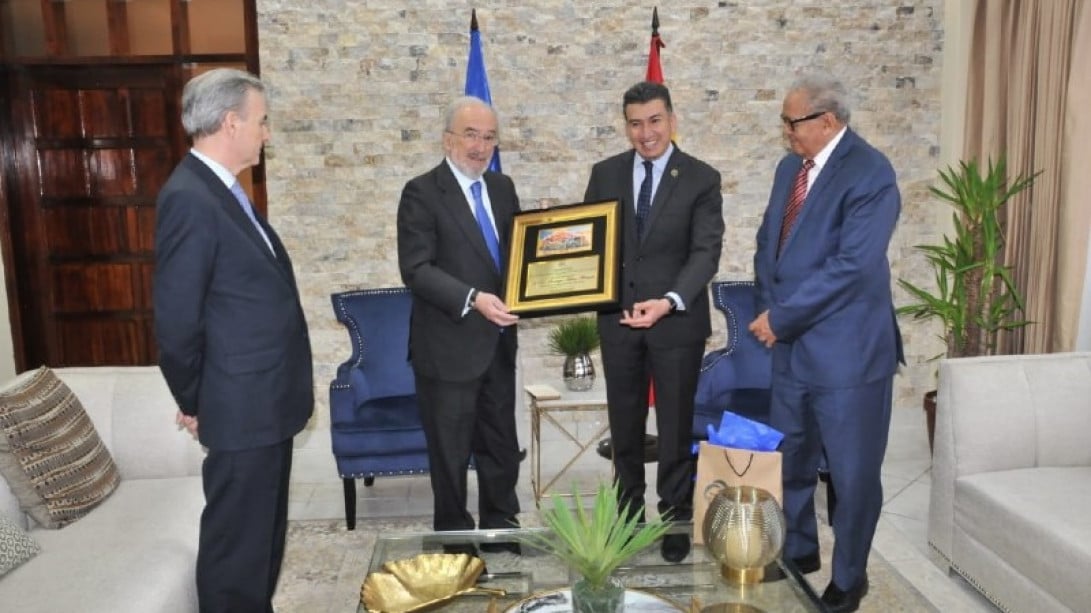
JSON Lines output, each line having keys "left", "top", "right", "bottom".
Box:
{"left": 754, "top": 130, "right": 903, "bottom": 387}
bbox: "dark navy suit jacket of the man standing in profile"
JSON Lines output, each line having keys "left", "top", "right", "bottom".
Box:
{"left": 153, "top": 154, "right": 314, "bottom": 450}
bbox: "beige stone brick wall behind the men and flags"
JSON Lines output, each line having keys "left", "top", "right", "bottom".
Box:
{"left": 257, "top": 0, "right": 947, "bottom": 431}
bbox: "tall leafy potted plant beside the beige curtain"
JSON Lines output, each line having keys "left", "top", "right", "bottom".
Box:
{"left": 898, "top": 156, "right": 1039, "bottom": 448}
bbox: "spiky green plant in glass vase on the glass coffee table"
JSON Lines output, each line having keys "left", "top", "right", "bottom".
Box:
{"left": 523, "top": 483, "right": 672, "bottom": 613}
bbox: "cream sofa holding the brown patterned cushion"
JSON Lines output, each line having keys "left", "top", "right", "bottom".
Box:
{"left": 0, "top": 366, "right": 204, "bottom": 613}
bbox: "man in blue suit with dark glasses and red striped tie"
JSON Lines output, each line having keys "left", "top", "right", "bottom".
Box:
{"left": 750, "top": 76, "right": 902, "bottom": 611}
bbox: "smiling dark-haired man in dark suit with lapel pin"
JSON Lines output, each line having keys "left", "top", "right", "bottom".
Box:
{"left": 584, "top": 82, "right": 723, "bottom": 562}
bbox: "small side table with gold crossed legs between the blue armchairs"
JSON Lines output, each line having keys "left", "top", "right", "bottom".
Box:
{"left": 523, "top": 383, "right": 610, "bottom": 507}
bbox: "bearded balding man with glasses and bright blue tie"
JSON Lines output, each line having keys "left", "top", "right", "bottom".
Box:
{"left": 398, "top": 97, "right": 520, "bottom": 530}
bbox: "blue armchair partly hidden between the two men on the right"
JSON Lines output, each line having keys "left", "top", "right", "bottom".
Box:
{"left": 693, "top": 281, "right": 772, "bottom": 441}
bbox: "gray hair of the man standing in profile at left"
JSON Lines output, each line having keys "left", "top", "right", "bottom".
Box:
{"left": 182, "top": 68, "right": 265, "bottom": 137}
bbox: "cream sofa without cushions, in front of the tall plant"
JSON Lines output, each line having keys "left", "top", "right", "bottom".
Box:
{"left": 928, "top": 353, "right": 1091, "bottom": 613}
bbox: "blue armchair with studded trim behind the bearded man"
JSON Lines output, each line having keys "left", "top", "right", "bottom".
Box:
{"left": 329, "top": 288, "right": 428, "bottom": 530}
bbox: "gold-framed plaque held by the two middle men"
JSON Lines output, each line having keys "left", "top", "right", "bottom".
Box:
{"left": 504, "top": 200, "right": 621, "bottom": 317}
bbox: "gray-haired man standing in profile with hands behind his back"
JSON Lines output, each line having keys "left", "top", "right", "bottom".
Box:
{"left": 153, "top": 69, "right": 314, "bottom": 613}
